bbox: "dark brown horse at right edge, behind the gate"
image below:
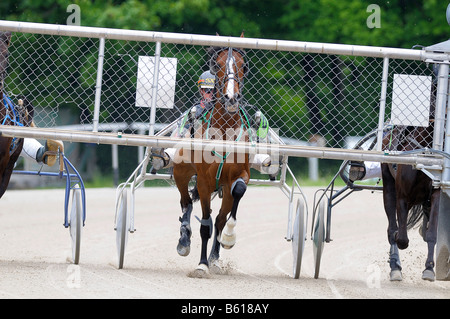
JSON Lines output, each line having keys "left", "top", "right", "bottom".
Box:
{"left": 381, "top": 73, "right": 440, "bottom": 281}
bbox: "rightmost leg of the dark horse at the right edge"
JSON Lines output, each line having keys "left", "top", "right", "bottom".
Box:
{"left": 422, "top": 189, "right": 440, "bottom": 281}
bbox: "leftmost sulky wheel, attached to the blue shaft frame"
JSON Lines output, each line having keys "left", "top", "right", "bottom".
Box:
{"left": 69, "top": 188, "right": 83, "bottom": 264}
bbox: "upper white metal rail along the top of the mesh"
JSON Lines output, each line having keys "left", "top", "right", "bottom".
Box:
{"left": 0, "top": 20, "right": 449, "bottom": 61}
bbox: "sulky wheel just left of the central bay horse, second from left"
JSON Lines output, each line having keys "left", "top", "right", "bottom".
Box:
{"left": 116, "top": 188, "right": 130, "bottom": 269}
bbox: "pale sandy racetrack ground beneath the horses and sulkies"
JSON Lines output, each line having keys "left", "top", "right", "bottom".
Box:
{"left": 0, "top": 186, "right": 450, "bottom": 299}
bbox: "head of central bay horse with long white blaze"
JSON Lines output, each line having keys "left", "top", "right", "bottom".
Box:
{"left": 208, "top": 33, "right": 248, "bottom": 114}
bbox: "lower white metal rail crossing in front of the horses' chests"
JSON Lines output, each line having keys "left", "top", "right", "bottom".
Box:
{"left": 0, "top": 125, "right": 443, "bottom": 166}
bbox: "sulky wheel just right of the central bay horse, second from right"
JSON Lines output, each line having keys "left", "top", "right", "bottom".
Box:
{"left": 292, "top": 198, "right": 306, "bottom": 279}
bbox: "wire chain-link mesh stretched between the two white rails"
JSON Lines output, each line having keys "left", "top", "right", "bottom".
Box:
{"left": 1, "top": 33, "right": 433, "bottom": 154}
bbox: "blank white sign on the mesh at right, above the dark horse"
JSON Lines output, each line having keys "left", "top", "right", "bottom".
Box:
{"left": 391, "top": 74, "right": 431, "bottom": 127}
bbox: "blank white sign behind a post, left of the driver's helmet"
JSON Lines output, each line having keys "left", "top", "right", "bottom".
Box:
{"left": 136, "top": 56, "right": 178, "bottom": 109}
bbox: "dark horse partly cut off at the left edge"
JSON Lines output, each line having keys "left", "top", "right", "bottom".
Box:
{"left": 0, "top": 32, "right": 33, "bottom": 198}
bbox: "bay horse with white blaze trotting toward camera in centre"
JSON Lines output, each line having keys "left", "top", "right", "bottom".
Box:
{"left": 173, "top": 35, "right": 250, "bottom": 277}
